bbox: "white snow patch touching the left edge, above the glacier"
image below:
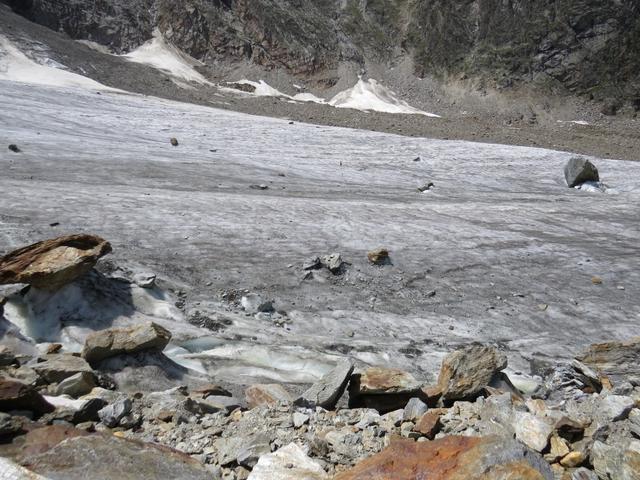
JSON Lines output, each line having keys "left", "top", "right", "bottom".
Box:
{"left": 0, "top": 35, "right": 122, "bottom": 92}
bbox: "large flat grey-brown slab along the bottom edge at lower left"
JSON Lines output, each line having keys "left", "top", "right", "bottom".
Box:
{"left": 24, "top": 434, "right": 212, "bottom": 480}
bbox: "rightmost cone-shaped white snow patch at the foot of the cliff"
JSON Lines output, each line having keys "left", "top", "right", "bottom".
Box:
{"left": 329, "top": 78, "right": 439, "bottom": 118}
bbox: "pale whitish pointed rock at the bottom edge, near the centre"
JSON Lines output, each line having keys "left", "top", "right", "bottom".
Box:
{"left": 248, "top": 443, "right": 329, "bottom": 480}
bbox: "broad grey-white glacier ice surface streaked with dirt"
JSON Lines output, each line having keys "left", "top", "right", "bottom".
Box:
{"left": 0, "top": 81, "right": 640, "bottom": 383}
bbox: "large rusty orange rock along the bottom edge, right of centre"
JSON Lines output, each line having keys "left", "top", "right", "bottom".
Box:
{"left": 335, "top": 436, "right": 553, "bottom": 480}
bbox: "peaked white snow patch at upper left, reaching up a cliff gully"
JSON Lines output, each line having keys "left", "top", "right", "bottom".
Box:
{"left": 123, "top": 29, "right": 214, "bottom": 86}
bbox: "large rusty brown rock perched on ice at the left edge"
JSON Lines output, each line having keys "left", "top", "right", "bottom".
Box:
{"left": 0, "top": 234, "right": 111, "bottom": 290}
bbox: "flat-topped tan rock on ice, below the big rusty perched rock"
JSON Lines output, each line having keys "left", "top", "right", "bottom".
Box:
{"left": 82, "top": 322, "right": 171, "bottom": 364}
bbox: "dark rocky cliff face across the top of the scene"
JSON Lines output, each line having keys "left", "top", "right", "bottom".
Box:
{"left": 3, "top": 0, "right": 640, "bottom": 106}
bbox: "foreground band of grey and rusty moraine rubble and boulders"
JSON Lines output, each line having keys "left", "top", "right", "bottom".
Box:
{"left": 0, "top": 237, "right": 640, "bottom": 480}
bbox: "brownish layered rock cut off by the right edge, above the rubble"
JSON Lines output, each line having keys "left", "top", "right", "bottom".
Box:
{"left": 577, "top": 337, "right": 640, "bottom": 385}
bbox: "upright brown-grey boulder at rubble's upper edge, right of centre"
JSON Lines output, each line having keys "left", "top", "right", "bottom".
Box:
{"left": 438, "top": 345, "right": 507, "bottom": 401}
